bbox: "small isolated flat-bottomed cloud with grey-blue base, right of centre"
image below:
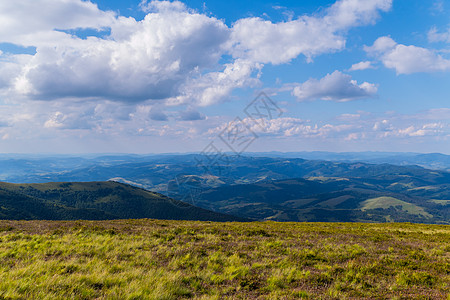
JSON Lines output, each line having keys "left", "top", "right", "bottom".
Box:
{"left": 292, "top": 71, "right": 377, "bottom": 102}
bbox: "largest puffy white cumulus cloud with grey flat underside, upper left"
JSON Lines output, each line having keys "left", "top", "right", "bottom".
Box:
{"left": 15, "top": 5, "right": 228, "bottom": 101}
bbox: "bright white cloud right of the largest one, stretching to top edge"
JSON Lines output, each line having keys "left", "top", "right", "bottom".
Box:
{"left": 232, "top": 0, "right": 392, "bottom": 64}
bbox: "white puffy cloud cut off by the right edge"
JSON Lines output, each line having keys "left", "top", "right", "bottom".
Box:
{"left": 364, "top": 36, "right": 450, "bottom": 74}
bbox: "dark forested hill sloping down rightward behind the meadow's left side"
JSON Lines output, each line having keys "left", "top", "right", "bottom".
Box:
{"left": 0, "top": 182, "right": 244, "bottom": 221}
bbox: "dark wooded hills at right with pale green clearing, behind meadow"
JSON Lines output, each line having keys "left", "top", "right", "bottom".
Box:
{"left": 195, "top": 177, "right": 450, "bottom": 224}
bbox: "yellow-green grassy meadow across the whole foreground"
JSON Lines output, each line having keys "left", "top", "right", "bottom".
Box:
{"left": 0, "top": 220, "right": 450, "bottom": 299}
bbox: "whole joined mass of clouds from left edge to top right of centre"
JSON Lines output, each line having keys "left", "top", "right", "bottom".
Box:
{"left": 0, "top": 0, "right": 391, "bottom": 106}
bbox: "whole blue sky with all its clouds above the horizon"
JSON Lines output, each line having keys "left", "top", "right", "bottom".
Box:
{"left": 0, "top": 0, "right": 450, "bottom": 154}
